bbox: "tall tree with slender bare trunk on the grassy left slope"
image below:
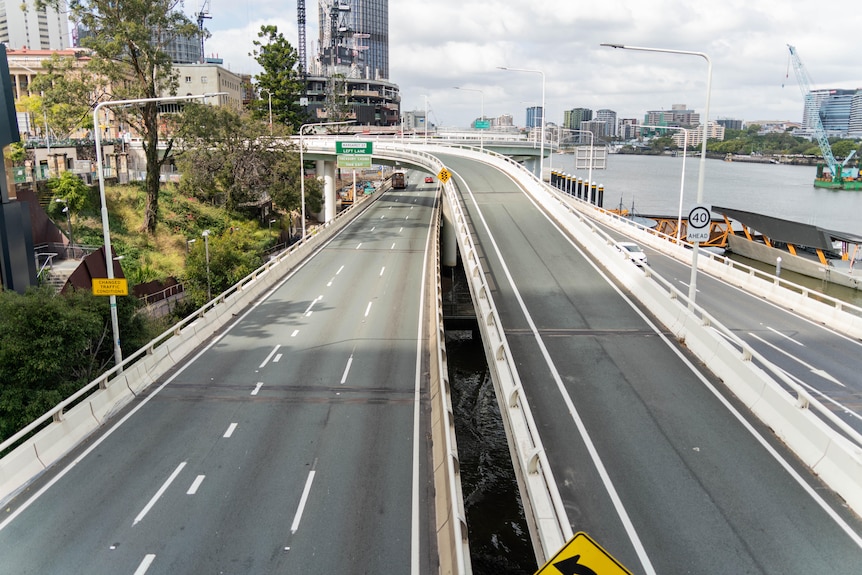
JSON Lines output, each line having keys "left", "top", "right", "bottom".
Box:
{"left": 40, "top": 0, "right": 205, "bottom": 234}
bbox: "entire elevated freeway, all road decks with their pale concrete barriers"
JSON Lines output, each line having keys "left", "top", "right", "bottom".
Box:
{"left": 0, "top": 138, "right": 862, "bottom": 575}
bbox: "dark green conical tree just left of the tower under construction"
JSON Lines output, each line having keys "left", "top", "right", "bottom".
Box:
{"left": 250, "top": 25, "right": 306, "bottom": 132}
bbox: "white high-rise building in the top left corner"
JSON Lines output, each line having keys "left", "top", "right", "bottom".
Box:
{"left": 0, "top": 0, "right": 71, "bottom": 50}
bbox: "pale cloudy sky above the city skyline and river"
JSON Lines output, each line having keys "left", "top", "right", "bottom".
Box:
{"left": 191, "top": 0, "right": 862, "bottom": 126}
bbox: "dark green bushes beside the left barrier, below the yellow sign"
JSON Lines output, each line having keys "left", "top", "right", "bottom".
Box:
{"left": 0, "top": 288, "right": 156, "bottom": 439}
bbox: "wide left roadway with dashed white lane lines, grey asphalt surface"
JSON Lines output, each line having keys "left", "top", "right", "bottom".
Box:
{"left": 0, "top": 186, "right": 437, "bottom": 575}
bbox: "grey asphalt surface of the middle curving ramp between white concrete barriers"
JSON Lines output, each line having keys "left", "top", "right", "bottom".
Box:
{"left": 441, "top": 155, "right": 862, "bottom": 575}
